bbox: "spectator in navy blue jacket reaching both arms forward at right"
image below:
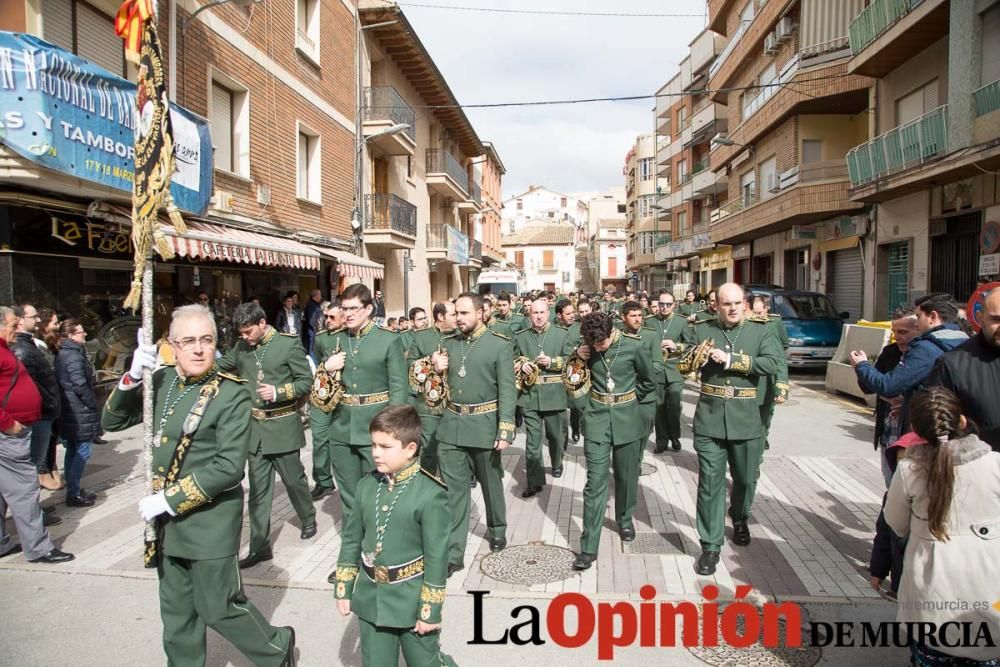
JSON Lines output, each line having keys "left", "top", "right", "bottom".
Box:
{"left": 851, "top": 294, "right": 968, "bottom": 424}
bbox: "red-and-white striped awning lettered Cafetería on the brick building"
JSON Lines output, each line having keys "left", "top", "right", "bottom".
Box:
{"left": 163, "top": 220, "right": 320, "bottom": 271}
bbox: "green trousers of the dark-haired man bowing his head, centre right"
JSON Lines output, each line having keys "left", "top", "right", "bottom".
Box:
{"left": 580, "top": 440, "right": 644, "bottom": 554}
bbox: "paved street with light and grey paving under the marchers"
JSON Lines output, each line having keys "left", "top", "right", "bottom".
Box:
{"left": 0, "top": 375, "right": 904, "bottom": 665}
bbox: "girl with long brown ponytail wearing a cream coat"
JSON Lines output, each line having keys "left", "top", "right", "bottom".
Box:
{"left": 885, "top": 386, "right": 1000, "bottom": 665}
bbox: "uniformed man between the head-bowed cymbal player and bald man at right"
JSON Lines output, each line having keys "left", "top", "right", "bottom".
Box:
{"left": 646, "top": 290, "right": 694, "bottom": 454}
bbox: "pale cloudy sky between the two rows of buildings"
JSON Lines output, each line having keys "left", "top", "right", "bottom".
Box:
{"left": 399, "top": 0, "right": 706, "bottom": 198}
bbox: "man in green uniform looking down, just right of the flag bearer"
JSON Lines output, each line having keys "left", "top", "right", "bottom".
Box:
{"left": 217, "top": 303, "right": 316, "bottom": 568}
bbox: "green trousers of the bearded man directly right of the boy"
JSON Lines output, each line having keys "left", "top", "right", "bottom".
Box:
{"left": 438, "top": 442, "right": 507, "bottom": 566}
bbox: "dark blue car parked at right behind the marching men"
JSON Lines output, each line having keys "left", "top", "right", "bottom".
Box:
{"left": 752, "top": 288, "right": 850, "bottom": 368}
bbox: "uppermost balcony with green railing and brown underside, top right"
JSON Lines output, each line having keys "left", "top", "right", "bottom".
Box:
{"left": 847, "top": 0, "right": 949, "bottom": 77}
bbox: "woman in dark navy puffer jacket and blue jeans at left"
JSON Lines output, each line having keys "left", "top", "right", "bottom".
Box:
{"left": 56, "top": 318, "right": 101, "bottom": 507}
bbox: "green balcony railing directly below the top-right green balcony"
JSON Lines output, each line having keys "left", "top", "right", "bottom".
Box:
{"left": 847, "top": 104, "right": 948, "bottom": 187}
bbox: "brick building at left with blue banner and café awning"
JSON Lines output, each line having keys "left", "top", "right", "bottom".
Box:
{"left": 0, "top": 0, "right": 372, "bottom": 333}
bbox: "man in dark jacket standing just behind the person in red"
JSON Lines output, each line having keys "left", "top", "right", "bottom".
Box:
{"left": 10, "top": 304, "right": 65, "bottom": 491}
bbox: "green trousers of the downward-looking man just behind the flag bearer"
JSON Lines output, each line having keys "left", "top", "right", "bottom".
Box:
{"left": 248, "top": 445, "right": 316, "bottom": 553}
